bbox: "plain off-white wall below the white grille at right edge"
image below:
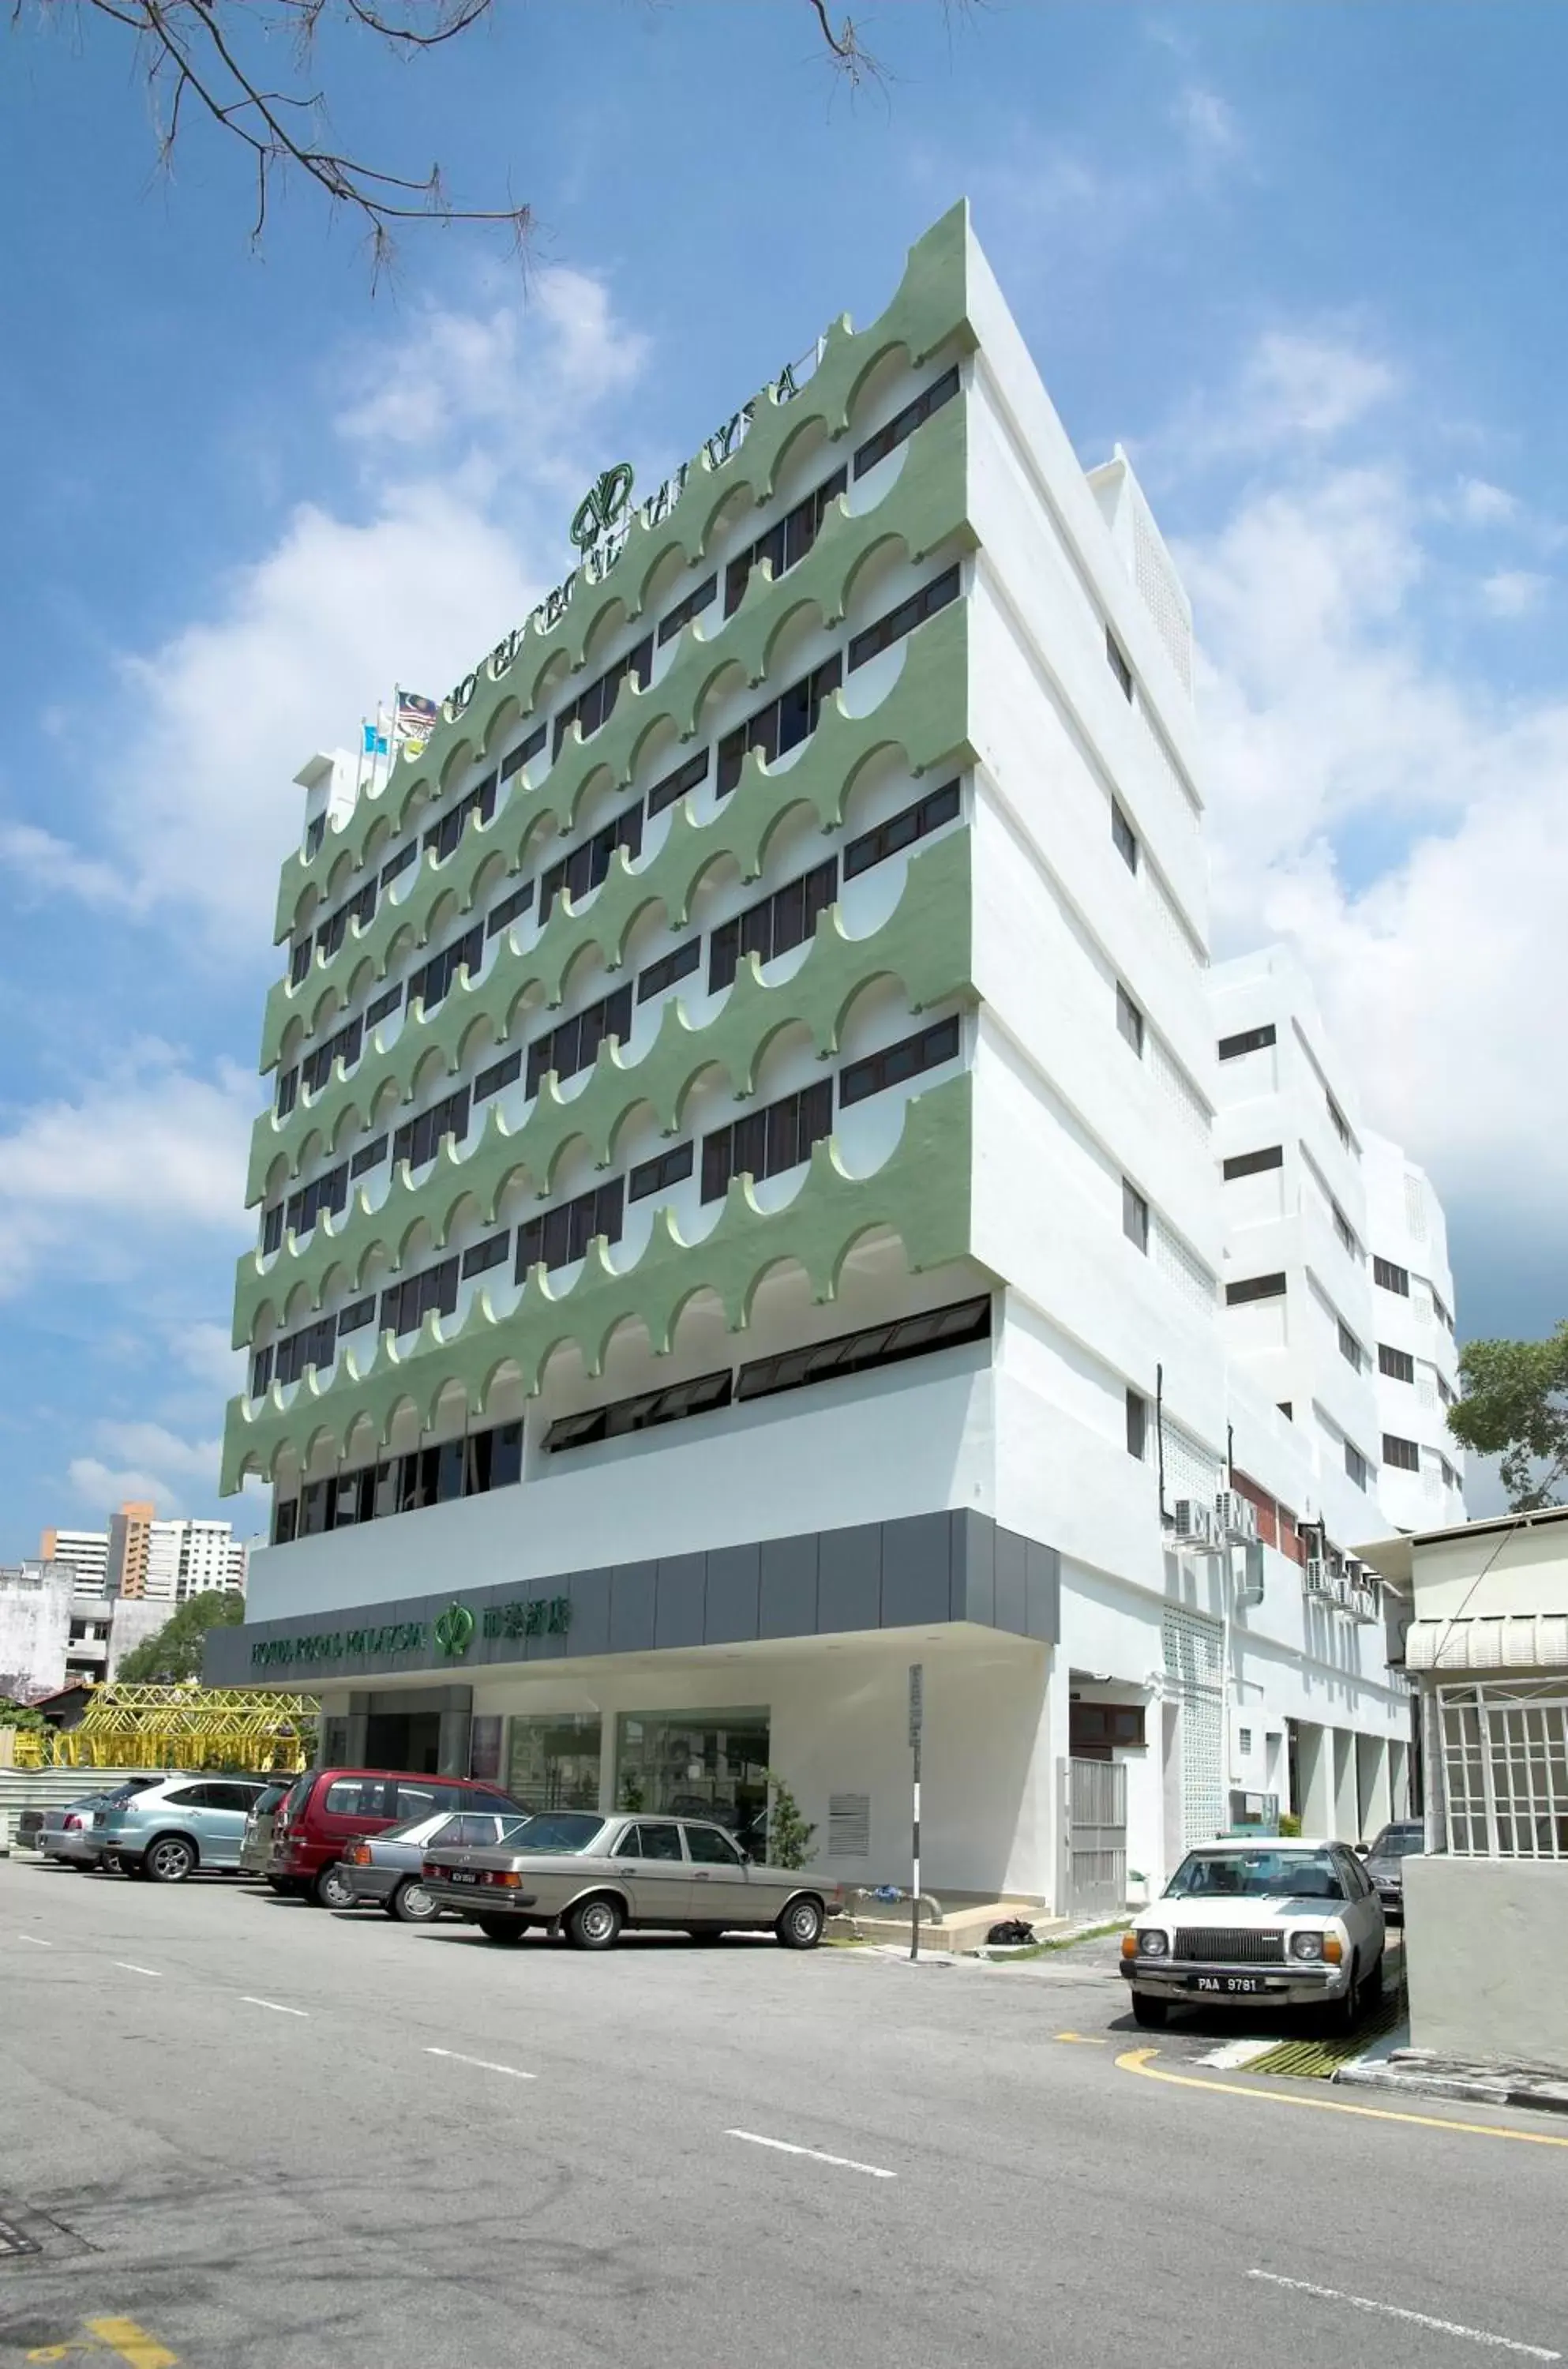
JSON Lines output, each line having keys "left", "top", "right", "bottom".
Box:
{"left": 1405, "top": 1857, "right": 1568, "bottom": 2071}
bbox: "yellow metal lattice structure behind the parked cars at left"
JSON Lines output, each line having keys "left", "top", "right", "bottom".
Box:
{"left": 17, "top": 1680, "right": 320, "bottom": 1770}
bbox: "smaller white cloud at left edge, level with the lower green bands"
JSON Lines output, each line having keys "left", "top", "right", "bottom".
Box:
{"left": 0, "top": 1045, "right": 256, "bottom": 1298}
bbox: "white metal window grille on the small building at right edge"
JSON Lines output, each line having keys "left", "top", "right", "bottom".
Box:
{"left": 1438, "top": 1680, "right": 1568, "bottom": 1860}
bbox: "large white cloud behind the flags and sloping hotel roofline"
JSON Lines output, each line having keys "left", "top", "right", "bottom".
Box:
{"left": 12, "top": 270, "right": 647, "bottom": 952}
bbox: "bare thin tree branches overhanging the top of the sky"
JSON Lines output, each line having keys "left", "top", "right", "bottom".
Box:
{"left": 12, "top": 0, "right": 914, "bottom": 270}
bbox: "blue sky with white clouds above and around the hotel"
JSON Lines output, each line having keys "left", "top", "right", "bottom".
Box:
{"left": 0, "top": 0, "right": 1568, "bottom": 1559}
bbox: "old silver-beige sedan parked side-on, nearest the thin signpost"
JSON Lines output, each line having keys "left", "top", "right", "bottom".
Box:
{"left": 424, "top": 1810, "right": 843, "bottom": 1950}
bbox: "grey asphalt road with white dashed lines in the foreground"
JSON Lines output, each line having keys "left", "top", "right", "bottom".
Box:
{"left": 0, "top": 1860, "right": 1568, "bottom": 2369}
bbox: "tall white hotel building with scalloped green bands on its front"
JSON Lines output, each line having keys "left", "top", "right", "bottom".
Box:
{"left": 208, "top": 208, "right": 1452, "bottom": 1909}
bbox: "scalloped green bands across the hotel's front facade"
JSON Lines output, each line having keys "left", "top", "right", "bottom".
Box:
{"left": 223, "top": 208, "right": 973, "bottom": 1490}
